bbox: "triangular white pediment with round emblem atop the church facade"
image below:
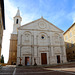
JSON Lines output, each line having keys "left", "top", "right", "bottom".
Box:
{"left": 18, "top": 18, "right": 63, "bottom": 32}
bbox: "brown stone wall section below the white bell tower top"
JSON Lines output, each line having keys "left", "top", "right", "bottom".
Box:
{"left": 8, "top": 34, "right": 17, "bottom": 65}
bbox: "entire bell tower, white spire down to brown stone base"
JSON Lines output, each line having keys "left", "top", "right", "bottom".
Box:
{"left": 8, "top": 9, "right": 22, "bottom": 65}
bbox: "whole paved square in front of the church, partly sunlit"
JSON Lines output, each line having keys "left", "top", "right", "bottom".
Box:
{"left": 0, "top": 64, "right": 75, "bottom": 75}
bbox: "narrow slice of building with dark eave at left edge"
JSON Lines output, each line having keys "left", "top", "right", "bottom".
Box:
{"left": 0, "top": 0, "right": 5, "bottom": 59}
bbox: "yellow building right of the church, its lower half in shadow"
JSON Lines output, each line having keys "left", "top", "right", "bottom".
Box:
{"left": 63, "top": 23, "right": 75, "bottom": 61}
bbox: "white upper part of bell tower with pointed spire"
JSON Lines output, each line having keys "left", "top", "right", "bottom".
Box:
{"left": 13, "top": 9, "right": 22, "bottom": 34}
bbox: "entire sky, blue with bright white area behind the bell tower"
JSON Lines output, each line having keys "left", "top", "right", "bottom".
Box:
{"left": 2, "top": 0, "right": 75, "bottom": 62}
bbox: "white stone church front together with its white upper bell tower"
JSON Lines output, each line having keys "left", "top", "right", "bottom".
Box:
{"left": 8, "top": 11, "right": 67, "bottom": 66}
